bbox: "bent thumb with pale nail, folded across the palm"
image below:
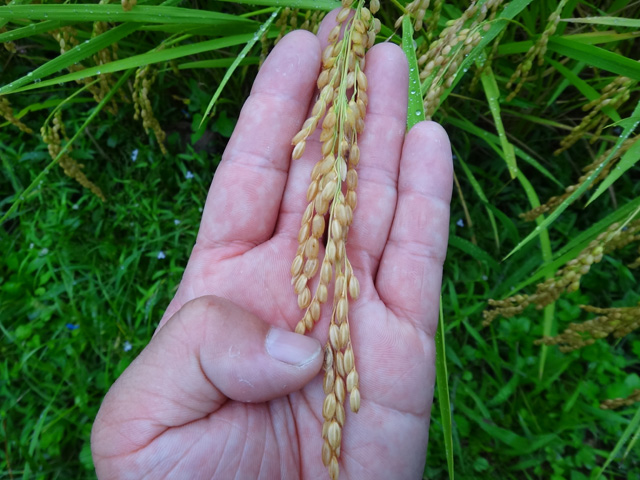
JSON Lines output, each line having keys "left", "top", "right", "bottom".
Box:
{"left": 92, "top": 296, "right": 322, "bottom": 458}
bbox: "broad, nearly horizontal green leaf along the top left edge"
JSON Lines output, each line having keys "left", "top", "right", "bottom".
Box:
{"left": 0, "top": 3, "right": 252, "bottom": 26}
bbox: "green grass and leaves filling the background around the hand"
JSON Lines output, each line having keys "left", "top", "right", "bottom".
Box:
{"left": 0, "top": 0, "right": 640, "bottom": 480}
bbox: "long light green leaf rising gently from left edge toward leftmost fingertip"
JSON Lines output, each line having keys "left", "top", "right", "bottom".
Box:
{"left": 0, "top": 33, "right": 262, "bottom": 94}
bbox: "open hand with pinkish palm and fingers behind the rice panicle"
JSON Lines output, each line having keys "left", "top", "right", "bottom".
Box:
{"left": 92, "top": 8, "right": 452, "bottom": 480}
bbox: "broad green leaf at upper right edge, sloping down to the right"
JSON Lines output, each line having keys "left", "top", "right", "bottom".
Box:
{"left": 549, "top": 37, "right": 640, "bottom": 80}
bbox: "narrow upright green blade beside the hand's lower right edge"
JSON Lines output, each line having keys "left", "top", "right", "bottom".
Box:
{"left": 436, "top": 296, "right": 454, "bottom": 480}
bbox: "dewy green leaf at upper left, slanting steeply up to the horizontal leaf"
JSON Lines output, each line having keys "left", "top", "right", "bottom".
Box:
{"left": 0, "top": 23, "right": 138, "bottom": 95}
